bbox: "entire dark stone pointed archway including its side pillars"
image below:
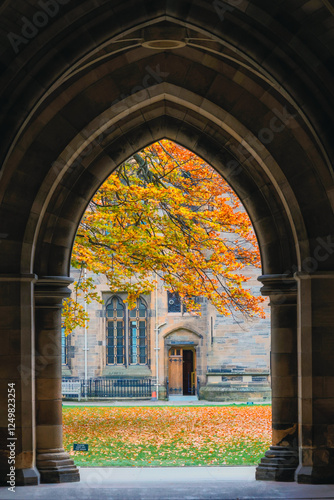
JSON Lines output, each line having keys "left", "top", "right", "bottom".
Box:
{"left": 0, "top": 0, "right": 334, "bottom": 484}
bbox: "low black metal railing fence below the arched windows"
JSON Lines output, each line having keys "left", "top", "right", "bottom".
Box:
{"left": 63, "top": 378, "right": 152, "bottom": 398}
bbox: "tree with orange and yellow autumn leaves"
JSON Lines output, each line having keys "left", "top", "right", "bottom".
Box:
{"left": 64, "top": 140, "right": 263, "bottom": 332}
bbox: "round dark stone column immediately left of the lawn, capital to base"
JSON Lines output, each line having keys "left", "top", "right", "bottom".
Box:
{"left": 35, "top": 277, "right": 80, "bottom": 483}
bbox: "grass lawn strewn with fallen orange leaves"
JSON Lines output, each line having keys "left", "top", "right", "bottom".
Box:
{"left": 63, "top": 405, "right": 271, "bottom": 467}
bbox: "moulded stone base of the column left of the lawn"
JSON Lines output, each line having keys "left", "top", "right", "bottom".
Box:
{"left": 37, "top": 448, "right": 80, "bottom": 483}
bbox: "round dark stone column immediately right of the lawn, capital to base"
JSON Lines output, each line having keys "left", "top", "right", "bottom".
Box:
{"left": 256, "top": 275, "right": 298, "bottom": 481}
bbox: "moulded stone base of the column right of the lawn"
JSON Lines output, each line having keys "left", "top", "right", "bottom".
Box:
{"left": 255, "top": 446, "right": 298, "bottom": 482}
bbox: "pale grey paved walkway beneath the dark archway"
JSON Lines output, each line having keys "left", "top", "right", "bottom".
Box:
{"left": 0, "top": 467, "right": 334, "bottom": 500}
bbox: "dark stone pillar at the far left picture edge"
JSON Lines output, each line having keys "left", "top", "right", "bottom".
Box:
{"left": 0, "top": 275, "right": 39, "bottom": 486}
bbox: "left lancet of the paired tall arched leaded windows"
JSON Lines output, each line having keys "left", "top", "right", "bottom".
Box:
{"left": 106, "top": 297, "right": 125, "bottom": 365}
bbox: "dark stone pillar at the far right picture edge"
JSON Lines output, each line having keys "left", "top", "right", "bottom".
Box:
{"left": 296, "top": 272, "right": 334, "bottom": 484}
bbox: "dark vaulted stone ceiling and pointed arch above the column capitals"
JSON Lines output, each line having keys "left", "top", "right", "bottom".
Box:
{"left": 0, "top": 0, "right": 334, "bottom": 275}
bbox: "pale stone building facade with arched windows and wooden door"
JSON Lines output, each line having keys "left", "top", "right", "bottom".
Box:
{"left": 62, "top": 267, "right": 271, "bottom": 401}
